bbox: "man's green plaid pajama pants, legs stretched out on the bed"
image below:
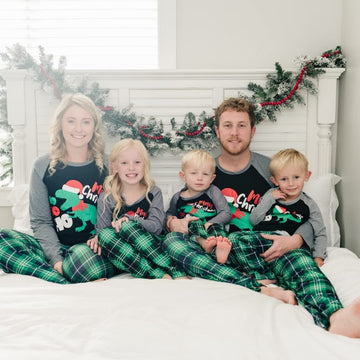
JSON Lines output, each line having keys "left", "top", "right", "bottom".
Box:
{"left": 163, "top": 232, "right": 342, "bottom": 329}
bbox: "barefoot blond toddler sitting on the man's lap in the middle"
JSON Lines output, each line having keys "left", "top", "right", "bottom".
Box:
{"left": 166, "top": 150, "right": 231, "bottom": 264}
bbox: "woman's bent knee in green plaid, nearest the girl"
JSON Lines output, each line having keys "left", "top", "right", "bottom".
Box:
{"left": 62, "top": 244, "right": 116, "bottom": 283}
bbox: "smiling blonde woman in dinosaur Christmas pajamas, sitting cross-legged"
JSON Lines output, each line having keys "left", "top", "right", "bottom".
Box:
{"left": 0, "top": 94, "right": 114, "bottom": 284}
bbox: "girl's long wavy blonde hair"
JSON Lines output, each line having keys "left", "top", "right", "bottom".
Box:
{"left": 104, "top": 139, "right": 155, "bottom": 220}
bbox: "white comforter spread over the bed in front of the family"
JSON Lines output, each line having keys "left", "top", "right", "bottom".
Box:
{"left": 0, "top": 248, "right": 360, "bottom": 360}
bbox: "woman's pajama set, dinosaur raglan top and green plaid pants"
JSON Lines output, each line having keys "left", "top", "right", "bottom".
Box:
{"left": 0, "top": 155, "right": 116, "bottom": 284}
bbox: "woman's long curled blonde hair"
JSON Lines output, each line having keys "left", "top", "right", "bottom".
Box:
{"left": 49, "top": 93, "right": 105, "bottom": 174}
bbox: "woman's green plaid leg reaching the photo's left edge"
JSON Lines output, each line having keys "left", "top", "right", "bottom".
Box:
{"left": 0, "top": 229, "right": 69, "bottom": 284}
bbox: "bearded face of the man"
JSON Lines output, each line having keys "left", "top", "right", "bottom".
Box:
{"left": 215, "top": 110, "right": 256, "bottom": 155}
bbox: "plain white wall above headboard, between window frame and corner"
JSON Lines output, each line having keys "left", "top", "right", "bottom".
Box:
{"left": 177, "top": 0, "right": 342, "bottom": 69}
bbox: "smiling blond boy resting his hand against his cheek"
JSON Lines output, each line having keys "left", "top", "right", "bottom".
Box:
{"left": 233, "top": 149, "right": 327, "bottom": 280}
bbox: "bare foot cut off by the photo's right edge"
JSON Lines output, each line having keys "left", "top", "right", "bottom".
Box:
{"left": 329, "top": 298, "right": 360, "bottom": 338}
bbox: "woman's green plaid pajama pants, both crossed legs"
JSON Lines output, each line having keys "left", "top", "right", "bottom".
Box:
{"left": 0, "top": 229, "right": 116, "bottom": 284}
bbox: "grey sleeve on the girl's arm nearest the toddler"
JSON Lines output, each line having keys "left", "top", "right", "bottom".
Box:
{"left": 128, "top": 186, "right": 165, "bottom": 235}
